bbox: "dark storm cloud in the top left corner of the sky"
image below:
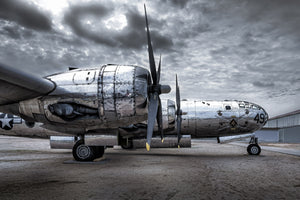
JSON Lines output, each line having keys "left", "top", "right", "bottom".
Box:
{"left": 0, "top": 0, "right": 51, "bottom": 31}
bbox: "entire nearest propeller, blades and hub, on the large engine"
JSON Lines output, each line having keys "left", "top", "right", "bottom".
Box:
{"left": 144, "top": 5, "right": 171, "bottom": 151}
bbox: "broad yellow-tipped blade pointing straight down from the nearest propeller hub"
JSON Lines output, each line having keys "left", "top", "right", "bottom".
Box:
{"left": 146, "top": 92, "right": 159, "bottom": 151}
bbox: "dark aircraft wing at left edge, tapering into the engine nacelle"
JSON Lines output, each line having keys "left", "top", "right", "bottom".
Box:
{"left": 0, "top": 64, "right": 56, "bottom": 106}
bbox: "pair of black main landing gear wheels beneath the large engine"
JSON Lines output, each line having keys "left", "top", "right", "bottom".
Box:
{"left": 72, "top": 139, "right": 104, "bottom": 161}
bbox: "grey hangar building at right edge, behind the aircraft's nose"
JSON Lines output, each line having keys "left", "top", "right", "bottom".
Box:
{"left": 255, "top": 110, "right": 300, "bottom": 143}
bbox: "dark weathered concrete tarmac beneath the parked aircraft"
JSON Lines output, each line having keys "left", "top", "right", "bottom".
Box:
{"left": 0, "top": 136, "right": 300, "bottom": 200}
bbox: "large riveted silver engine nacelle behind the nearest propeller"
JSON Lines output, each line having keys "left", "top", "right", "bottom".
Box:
{"left": 19, "top": 65, "right": 149, "bottom": 132}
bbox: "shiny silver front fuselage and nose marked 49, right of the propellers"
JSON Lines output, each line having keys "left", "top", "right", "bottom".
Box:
{"left": 181, "top": 100, "right": 268, "bottom": 137}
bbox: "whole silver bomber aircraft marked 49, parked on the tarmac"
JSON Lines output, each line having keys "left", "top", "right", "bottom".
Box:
{"left": 0, "top": 7, "right": 267, "bottom": 161}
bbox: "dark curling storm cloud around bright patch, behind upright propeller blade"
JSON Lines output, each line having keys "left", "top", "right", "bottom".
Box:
{"left": 64, "top": 4, "right": 173, "bottom": 49}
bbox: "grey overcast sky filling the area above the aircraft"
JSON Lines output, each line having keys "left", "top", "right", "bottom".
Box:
{"left": 0, "top": 0, "right": 300, "bottom": 117}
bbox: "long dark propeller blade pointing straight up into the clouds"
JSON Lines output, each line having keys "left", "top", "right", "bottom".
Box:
{"left": 144, "top": 4, "right": 157, "bottom": 85}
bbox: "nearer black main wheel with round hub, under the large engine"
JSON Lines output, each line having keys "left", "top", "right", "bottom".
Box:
{"left": 72, "top": 140, "right": 95, "bottom": 161}
